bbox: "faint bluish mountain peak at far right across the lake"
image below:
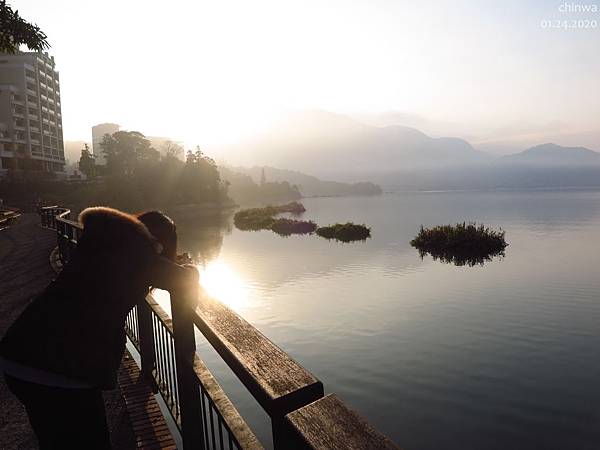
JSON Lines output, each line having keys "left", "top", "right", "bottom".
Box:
{"left": 500, "top": 144, "right": 600, "bottom": 167}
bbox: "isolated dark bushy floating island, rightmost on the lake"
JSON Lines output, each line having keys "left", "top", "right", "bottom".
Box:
{"left": 410, "top": 222, "right": 508, "bottom": 267}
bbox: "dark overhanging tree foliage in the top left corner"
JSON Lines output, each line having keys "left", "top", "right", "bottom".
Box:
{"left": 0, "top": 0, "right": 50, "bottom": 53}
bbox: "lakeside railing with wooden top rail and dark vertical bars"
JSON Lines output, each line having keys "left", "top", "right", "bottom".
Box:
{"left": 40, "top": 206, "right": 398, "bottom": 450}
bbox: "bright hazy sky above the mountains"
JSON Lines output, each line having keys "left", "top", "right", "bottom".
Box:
{"left": 10, "top": 0, "right": 600, "bottom": 150}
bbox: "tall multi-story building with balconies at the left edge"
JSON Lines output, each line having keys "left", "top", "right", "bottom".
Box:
{"left": 0, "top": 52, "right": 65, "bottom": 175}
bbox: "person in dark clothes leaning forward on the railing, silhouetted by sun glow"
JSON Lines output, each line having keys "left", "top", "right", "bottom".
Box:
{"left": 0, "top": 207, "right": 198, "bottom": 450}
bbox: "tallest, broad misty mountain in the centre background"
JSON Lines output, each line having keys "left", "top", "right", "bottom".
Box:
{"left": 222, "top": 111, "right": 493, "bottom": 178}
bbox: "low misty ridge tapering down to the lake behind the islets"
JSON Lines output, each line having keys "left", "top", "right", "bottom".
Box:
{"left": 231, "top": 166, "right": 382, "bottom": 197}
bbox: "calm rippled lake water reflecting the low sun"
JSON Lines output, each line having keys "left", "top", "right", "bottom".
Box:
{"left": 156, "top": 191, "right": 600, "bottom": 450}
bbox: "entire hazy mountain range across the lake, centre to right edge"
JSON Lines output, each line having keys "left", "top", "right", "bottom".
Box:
{"left": 217, "top": 111, "right": 600, "bottom": 189}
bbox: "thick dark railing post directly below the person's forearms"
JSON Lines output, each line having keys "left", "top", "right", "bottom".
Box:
{"left": 171, "top": 289, "right": 205, "bottom": 450}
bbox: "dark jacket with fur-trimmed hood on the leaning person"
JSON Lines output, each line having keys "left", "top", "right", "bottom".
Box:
{"left": 0, "top": 208, "right": 193, "bottom": 389}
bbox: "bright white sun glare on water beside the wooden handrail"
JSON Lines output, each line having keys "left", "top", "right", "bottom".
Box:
{"left": 198, "top": 260, "right": 249, "bottom": 310}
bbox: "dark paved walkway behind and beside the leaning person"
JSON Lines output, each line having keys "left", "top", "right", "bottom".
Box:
{"left": 0, "top": 214, "right": 136, "bottom": 450}
